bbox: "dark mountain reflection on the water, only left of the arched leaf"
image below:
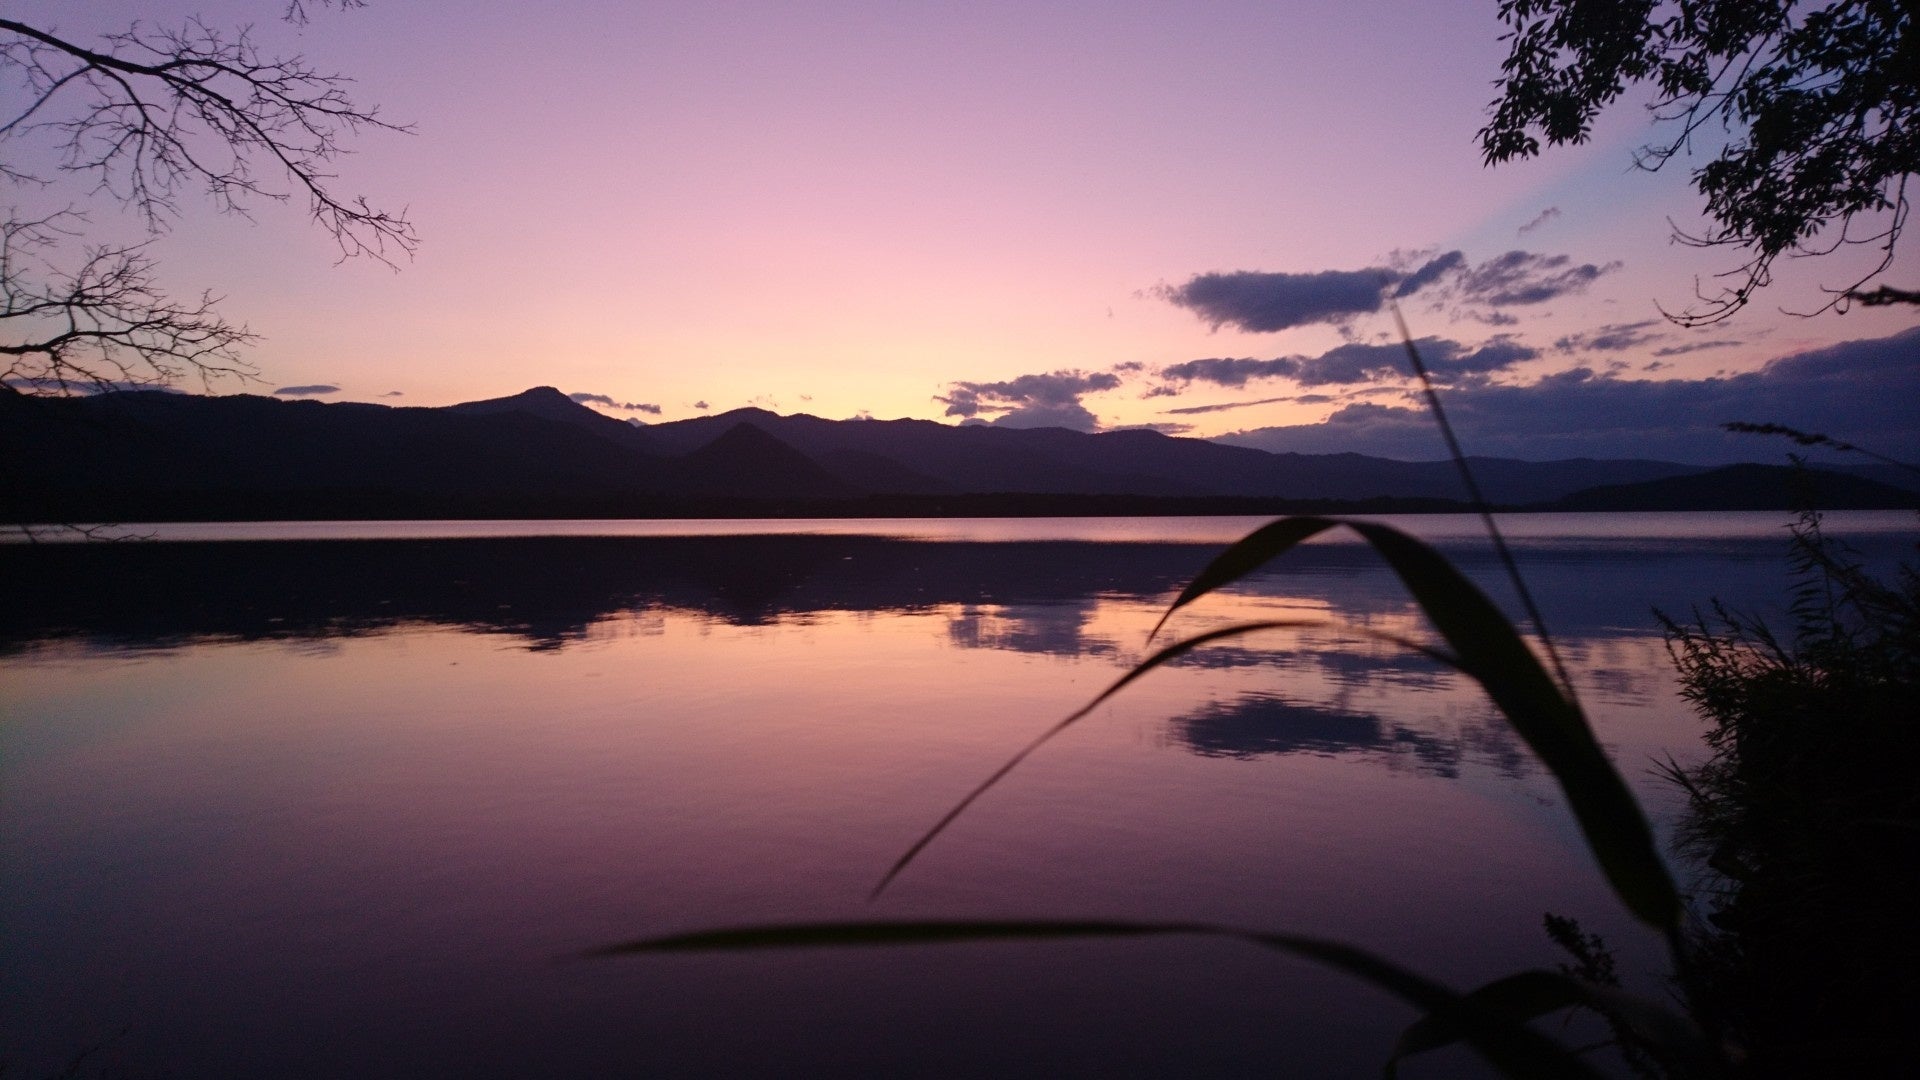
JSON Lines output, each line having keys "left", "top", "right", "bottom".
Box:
{"left": 0, "top": 536, "right": 1213, "bottom": 655}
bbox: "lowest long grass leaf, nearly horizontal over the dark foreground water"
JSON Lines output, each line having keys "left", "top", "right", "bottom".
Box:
{"left": 584, "top": 920, "right": 1599, "bottom": 1080}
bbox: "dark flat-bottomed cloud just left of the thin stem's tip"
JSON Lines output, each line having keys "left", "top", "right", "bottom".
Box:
{"left": 1160, "top": 267, "right": 1394, "bottom": 332}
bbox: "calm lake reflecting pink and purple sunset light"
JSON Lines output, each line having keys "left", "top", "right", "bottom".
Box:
{"left": 0, "top": 513, "right": 1914, "bottom": 1080}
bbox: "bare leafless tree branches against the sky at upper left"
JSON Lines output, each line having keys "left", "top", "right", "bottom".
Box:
{"left": 0, "top": 0, "right": 408, "bottom": 394}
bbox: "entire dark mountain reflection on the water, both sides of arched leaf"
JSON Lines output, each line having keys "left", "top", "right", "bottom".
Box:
{"left": 0, "top": 534, "right": 1843, "bottom": 653}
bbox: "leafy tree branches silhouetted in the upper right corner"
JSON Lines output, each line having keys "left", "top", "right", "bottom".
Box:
{"left": 1480, "top": 0, "right": 1920, "bottom": 325}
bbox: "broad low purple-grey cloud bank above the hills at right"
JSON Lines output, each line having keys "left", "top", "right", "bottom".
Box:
{"left": 1221, "top": 329, "right": 1920, "bottom": 465}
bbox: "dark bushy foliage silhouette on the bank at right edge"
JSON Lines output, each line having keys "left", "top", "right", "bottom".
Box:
{"left": 1663, "top": 511, "right": 1920, "bottom": 1076}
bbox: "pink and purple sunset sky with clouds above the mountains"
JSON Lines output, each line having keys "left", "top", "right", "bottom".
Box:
{"left": 0, "top": 0, "right": 1920, "bottom": 461}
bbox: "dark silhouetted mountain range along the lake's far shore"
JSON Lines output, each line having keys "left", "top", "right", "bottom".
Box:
{"left": 0, "top": 386, "right": 1920, "bottom": 521}
